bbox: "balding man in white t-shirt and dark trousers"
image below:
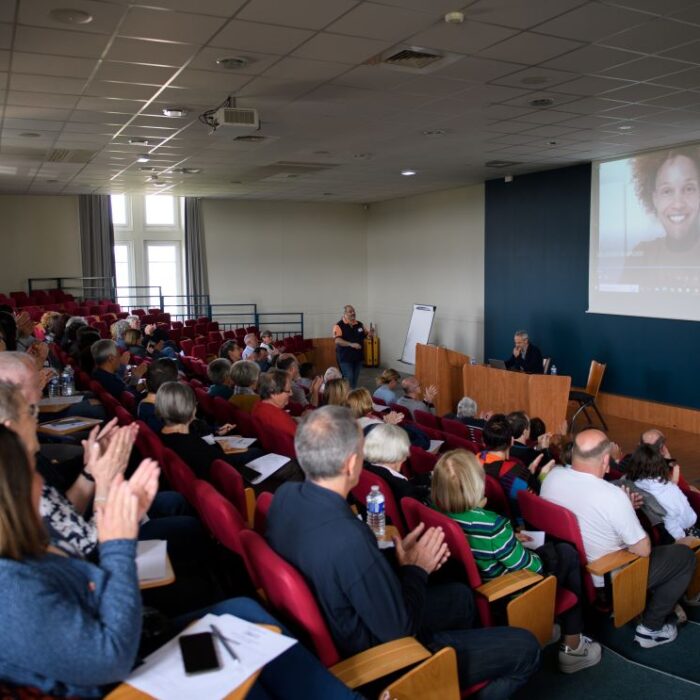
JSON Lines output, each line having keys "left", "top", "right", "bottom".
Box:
{"left": 540, "top": 430, "right": 695, "bottom": 648}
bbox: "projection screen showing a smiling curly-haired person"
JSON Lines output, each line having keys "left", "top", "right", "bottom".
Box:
{"left": 588, "top": 144, "right": 700, "bottom": 321}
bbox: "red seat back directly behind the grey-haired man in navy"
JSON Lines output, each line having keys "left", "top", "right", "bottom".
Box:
{"left": 240, "top": 530, "right": 340, "bottom": 666}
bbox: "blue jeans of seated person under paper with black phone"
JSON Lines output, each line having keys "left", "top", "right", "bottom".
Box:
{"left": 173, "top": 598, "right": 362, "bottom": 700}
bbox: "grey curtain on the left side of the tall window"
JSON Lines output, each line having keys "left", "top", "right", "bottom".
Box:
{"left": 79, "top": 194, "right": 115, "bottom": 299}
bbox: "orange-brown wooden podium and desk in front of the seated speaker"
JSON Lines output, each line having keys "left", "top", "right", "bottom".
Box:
{"left": 416, "top": 344, "right": 571, "bottom": 432}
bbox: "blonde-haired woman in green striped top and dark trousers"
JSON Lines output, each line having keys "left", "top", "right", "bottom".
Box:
{"left": 431, "top": 450, "right": 601, "bottom": 673}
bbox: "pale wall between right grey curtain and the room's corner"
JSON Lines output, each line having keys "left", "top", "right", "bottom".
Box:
{"left": 203, "top": 199, "right": 367, "bottom": 338}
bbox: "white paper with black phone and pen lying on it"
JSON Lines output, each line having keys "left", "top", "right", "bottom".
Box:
{"left": 126, "top": 615, "right": 296, "bottom": 700}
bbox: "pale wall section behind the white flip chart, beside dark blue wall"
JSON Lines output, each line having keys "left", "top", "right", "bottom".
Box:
{"left": 363, "top": 185, "right": 484, "bottom": 371}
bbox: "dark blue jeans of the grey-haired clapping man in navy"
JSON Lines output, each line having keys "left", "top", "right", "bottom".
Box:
{"left": 418, "top": 583, "right": 540, "bottom": 700}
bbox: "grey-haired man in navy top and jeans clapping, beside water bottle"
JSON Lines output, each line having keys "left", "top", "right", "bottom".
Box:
{"left": 267, "top": 406, "right": 539, "bottom": 700}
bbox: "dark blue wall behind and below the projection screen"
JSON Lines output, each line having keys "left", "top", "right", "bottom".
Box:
{"left": 484, "top": 165, "right": 700, "bottom": 408}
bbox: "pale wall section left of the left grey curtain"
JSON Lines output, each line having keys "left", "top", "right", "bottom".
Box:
{"left": 0, "top": 195, "right": 82, "bottom": 293}
